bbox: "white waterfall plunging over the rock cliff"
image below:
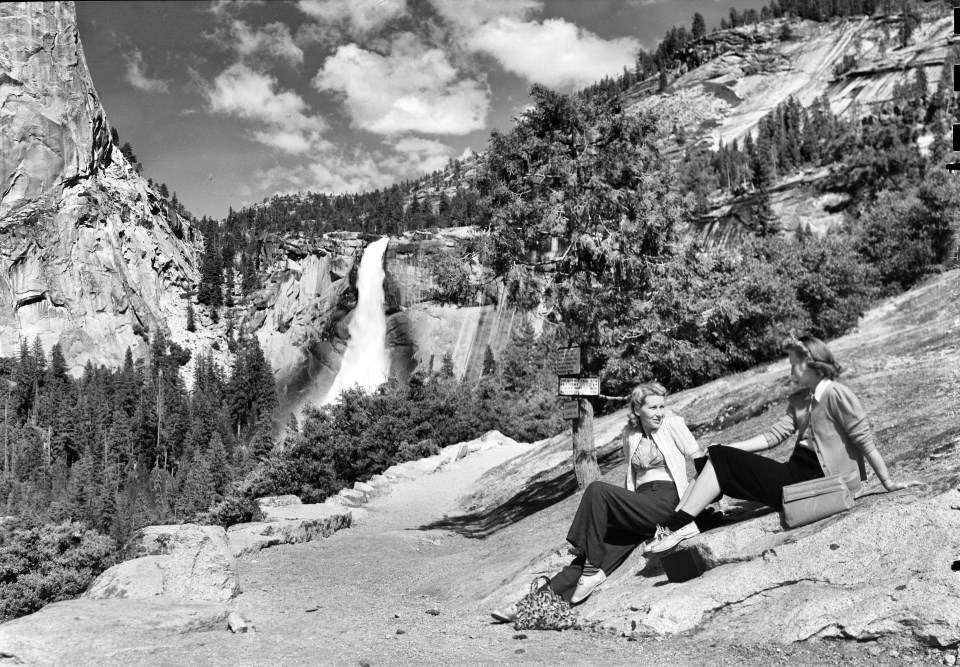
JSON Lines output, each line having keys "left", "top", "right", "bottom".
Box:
{"left": 323, "top": 236, "right": 390, "bottom": 405}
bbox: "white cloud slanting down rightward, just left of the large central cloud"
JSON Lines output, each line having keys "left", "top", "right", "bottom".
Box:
{"left": 205, "top": 63, "right": 328, "bottom": 154}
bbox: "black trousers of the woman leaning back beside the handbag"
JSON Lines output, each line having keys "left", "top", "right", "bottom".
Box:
{"left": 707, "top": 445, "right": 823, "bottom": 509}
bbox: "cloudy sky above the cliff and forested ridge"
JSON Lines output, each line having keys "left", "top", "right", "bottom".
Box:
{"left": 76, "top": 0, "right": 767, "bottom": 218}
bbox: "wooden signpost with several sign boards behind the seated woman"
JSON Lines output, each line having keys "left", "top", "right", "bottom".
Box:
{"left": 556, "top": 345, "right": 600, "bottom": 489}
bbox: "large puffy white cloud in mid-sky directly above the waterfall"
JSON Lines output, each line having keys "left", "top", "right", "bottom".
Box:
{"left": 313, "top": 33, "right": 490, "bottom": 135}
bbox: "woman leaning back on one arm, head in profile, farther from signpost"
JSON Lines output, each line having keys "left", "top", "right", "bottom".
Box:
{"left": 644, "top": 336, "right": 919, "bottom": 553}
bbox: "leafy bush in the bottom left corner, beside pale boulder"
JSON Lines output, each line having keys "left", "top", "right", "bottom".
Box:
{"left": 0, "top": 518, "right": 115, "bottom": 622}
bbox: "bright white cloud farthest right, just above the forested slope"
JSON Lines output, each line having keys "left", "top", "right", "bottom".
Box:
{"left": 467, "top": 17, "right": 640, "bottom": 89}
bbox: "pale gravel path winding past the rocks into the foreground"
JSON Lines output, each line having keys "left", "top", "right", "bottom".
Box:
{"left": 118, "top": 445, "right": 928, "bottom": 667}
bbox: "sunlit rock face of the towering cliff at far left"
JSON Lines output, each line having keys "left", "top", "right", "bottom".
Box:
{"left": 0, "top": 2, "right": 203, "bottom": 369}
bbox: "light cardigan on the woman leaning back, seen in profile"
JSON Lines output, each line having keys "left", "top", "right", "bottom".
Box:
{"left": 763, "top": 382, "right": 877, "bottom": 492}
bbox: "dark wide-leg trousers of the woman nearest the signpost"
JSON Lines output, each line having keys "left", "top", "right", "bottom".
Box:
{"left": 549, "top": 482, "right": 680, "bottom": 602}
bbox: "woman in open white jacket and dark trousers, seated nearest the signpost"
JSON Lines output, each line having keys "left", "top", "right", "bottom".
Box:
{"left": 492, "top": 382, "right": 701, "bottom": 622}
